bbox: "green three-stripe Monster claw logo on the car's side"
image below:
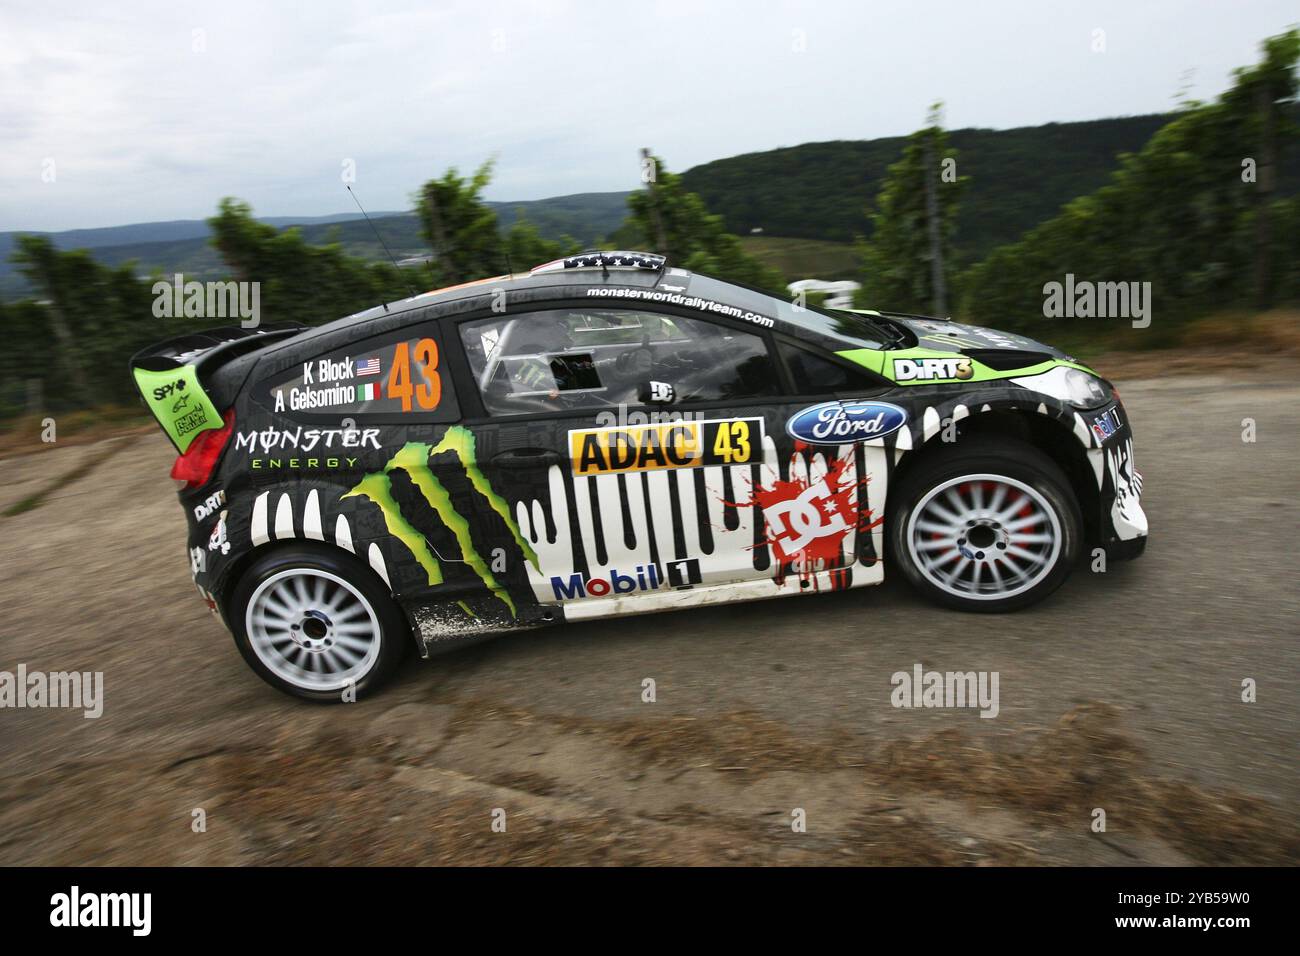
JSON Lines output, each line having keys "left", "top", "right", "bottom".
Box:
{"left": 343, "top": 425, "right": 537, "bottom": 617}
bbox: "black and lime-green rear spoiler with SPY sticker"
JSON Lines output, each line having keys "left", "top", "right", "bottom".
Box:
{"left": 130, "top": 323, "right": 307, "bottom": 455}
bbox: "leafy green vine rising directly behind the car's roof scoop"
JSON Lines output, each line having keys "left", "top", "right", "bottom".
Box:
{"left": 618, "top": 157, "right": 785, "bottom": 295}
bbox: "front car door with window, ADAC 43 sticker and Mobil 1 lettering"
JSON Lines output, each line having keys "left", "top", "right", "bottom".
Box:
{"left": 459, "top": 307, "right": 889, "bottom": 617}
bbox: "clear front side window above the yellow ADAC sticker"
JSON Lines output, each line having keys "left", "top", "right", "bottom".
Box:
{"left": 460, "top": 310, "right": 780, "bottom": 415}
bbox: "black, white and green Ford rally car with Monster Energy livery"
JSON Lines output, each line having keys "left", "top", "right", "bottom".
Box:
{"left": 131, "top": 252, "right": 1147, "bottom": 700}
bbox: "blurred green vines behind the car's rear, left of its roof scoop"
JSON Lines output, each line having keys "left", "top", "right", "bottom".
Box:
{"left": 0, "top": 165, "right": 590, "bottom": 416}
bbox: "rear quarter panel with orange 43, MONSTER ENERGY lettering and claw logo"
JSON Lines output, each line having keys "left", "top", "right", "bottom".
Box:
{"left": 244, "top": 310, "right": 515, "bottom": 623}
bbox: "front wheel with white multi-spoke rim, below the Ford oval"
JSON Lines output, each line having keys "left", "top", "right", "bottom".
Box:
{"left": 887, "top": 436, "right": 1083, "bottom": 613}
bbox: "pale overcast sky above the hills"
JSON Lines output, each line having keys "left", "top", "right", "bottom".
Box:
{"left": 0, "top": 0, "right": 1300, "bottom": 230}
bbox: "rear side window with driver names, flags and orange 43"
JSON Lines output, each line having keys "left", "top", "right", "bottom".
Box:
{"left": 269, "top": 325, "right": 460, "bottom": 421}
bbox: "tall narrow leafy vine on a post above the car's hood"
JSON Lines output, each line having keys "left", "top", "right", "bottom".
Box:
{"left": 858, "top": 103, "right": 970, "bottom": 315}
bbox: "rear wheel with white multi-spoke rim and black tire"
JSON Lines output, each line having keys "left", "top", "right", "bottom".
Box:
{"left": 225, "top": 542, "right": 411, "bottom": 704}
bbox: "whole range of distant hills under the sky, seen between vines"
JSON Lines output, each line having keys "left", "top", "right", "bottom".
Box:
{"left": 12, "top": 109, "right": 1300, "bottom": 299}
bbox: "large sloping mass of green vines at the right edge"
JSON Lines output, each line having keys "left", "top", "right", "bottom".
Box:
{"left": 961, "top": 31, "right": 1300, "bottom": 328}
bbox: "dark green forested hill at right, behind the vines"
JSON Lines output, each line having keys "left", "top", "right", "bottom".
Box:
{"left": 683, "top": 114, "right": 1297, "bottom": 263}
